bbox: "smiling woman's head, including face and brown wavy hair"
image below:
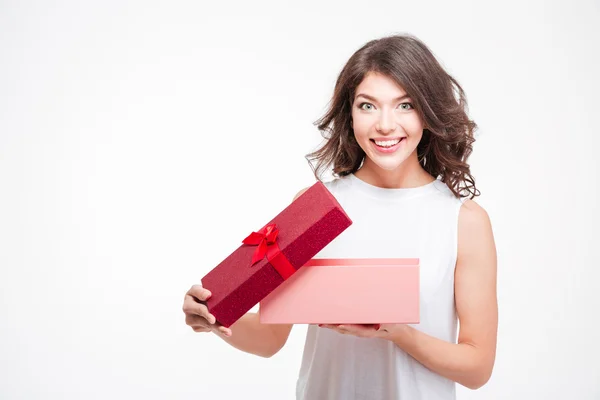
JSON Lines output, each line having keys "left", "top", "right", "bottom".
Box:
{"left": 308, "top": 35, "right": 479, "bottom": 197}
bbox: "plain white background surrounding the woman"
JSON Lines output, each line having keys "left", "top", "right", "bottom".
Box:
{"left": 0, "top": 1, "right": 600, "bottom": 400}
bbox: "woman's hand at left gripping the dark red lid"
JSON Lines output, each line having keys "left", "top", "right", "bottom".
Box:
{"left": 183, "top": 284, "right": 232, "bottom": 336}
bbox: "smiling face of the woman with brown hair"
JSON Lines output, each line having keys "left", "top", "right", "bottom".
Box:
{"left": 352, "top": 72, "right": 423, "bottom": 171}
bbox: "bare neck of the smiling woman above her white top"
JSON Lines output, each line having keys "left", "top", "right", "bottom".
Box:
{"left": 354, "top": 151, "right": 435, "bottom": 189}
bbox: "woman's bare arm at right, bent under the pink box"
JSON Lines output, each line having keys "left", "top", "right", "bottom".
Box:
{"left": 388, "top": 201, "right": 498, "bottom": 389}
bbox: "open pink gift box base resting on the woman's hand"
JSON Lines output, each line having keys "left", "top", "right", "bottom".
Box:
{"left": 260, "top": 258, "right": 420, "bottom": 324}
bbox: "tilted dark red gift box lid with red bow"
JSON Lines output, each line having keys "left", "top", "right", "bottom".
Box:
{"left": 201, "top": 181, "right": 352, "bottom": 327}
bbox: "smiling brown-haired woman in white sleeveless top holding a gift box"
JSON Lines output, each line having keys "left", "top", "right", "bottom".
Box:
{"left": 183, "top": 35, "right": 498, "bottom": 400}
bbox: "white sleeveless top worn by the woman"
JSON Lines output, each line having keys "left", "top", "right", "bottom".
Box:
{"left": 296, "top": 174, "right": 465, "bottom": 400}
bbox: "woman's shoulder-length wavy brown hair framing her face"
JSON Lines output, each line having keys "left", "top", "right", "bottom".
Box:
{"left": 306, "top": 34, "right": 480, "bottom": 199}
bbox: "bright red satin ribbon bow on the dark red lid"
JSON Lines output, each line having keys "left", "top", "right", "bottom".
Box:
{"left": 242, "top": 224, "right": 296, "bottom": 280}
